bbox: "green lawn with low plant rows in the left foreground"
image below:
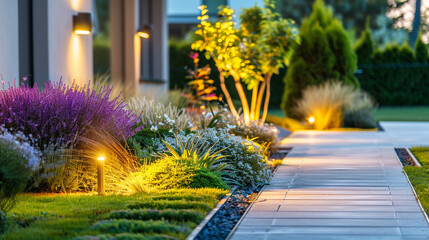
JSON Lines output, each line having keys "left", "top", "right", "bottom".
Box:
{"left": 0, "top": 189, "right": 226, "bottom": 240}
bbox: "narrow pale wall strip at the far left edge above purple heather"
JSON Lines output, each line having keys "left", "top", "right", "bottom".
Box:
{"left": 0, "top": 0, "right": 19, "bottom": 89}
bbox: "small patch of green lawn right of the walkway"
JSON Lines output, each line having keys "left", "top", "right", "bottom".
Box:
{"left": 404, "top": 147, "right": 429, "bottom": 214}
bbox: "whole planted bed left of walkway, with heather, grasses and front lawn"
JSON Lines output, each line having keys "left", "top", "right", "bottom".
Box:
{"left": 0, "top": 81, "right": 278, "bottom": 239}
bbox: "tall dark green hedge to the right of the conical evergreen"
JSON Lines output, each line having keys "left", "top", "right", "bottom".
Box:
{"left": 355, "top": 30, "right": 429, "bottom": 106}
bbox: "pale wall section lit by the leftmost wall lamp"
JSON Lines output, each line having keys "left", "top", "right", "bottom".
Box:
{"left": 48, "top": 0, "right": 93, "bottom": 85}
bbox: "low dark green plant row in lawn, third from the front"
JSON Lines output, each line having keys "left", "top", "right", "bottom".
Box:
{"left": 109, "top": 209, "right": 204, "bottom": 223}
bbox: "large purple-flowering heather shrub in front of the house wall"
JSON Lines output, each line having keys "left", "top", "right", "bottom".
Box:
{"left": 0, "top": 81, "right": 139, "bottom": 150}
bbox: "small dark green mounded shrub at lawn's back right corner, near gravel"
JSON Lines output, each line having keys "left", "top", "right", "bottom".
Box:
{"left": 189, "top": 168, "right": 228, "bottom": 189}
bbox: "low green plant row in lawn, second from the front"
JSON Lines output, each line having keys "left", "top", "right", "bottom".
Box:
{"left": 91, "top": 219, "right": 184, "bottom": 234}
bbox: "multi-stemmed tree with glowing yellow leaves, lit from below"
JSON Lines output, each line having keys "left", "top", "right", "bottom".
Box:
{"left": 192, "top": 0, "right": 298, "bottom": 124}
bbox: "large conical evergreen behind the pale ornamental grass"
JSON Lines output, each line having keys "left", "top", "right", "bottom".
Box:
{"left": 282, "top": 0, "right": 359, "bottom": 118}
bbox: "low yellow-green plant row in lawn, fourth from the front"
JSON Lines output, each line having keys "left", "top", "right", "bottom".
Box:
{"left": 127, "top": 198, "right": 211, "bottom": 211}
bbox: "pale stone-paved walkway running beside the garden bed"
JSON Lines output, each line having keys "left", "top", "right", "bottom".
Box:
{"left": 232, "top": 124, "right": 429, "bottom": 240}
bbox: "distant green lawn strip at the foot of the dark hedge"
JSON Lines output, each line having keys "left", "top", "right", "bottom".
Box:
{"left": 268, "top": 106, "right": 429, "bottom": 121}
